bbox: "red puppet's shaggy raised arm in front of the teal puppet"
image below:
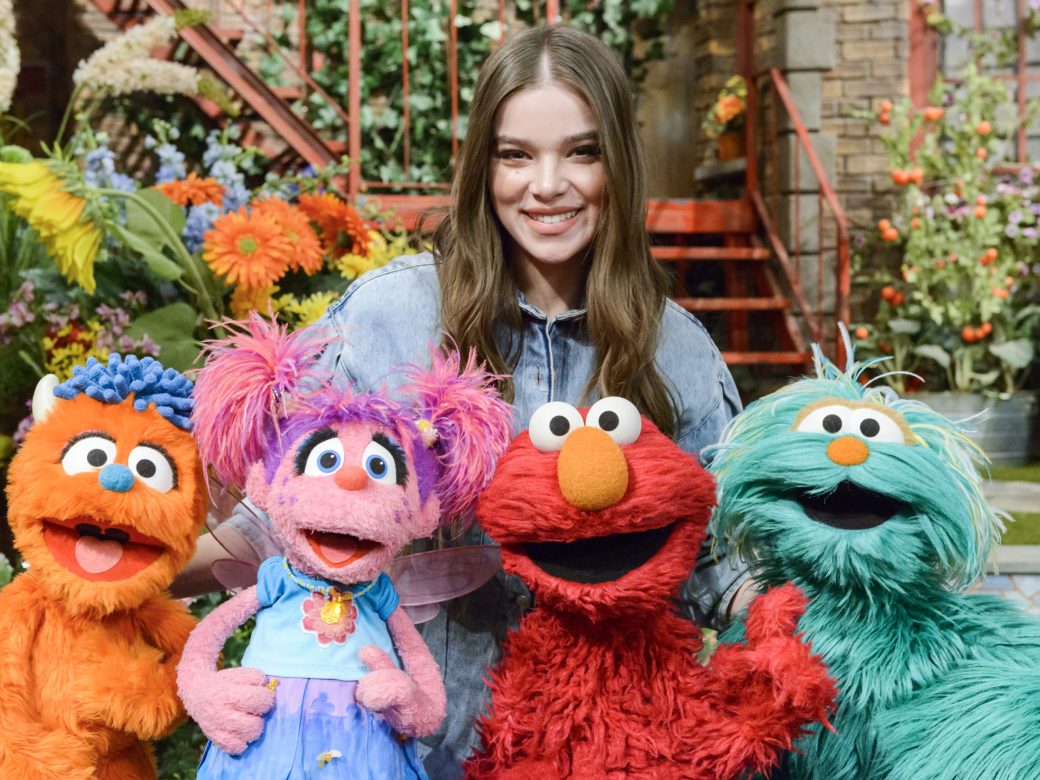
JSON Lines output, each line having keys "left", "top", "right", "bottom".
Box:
{"left": 697, "top": 583, "right": 835, "bottom": 778}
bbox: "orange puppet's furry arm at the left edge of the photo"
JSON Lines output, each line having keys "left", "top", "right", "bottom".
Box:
{"left": 0, "top": 574, "right": 96, "bottom": 780}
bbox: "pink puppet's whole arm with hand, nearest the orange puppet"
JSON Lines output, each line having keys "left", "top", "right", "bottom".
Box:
{"left": 177, "top": 587, "right": 275, "bottom": 755}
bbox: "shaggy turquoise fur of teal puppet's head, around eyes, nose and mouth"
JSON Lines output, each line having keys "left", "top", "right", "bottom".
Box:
{"left": 704, "top": 345, "right": 1003, "bottom": 589}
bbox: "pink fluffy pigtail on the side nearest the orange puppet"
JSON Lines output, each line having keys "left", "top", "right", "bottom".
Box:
{"left": 191, "top": 312, "right": 332, "bottom": 487}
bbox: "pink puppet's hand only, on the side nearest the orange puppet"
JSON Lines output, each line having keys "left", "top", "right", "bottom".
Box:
{"left": 181, "top": 667, "right": 275, "bottom": 756}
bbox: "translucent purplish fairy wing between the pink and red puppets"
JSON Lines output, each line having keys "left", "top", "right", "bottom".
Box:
{"left": 390, "top": 545, "right": 502, "bottom": 623}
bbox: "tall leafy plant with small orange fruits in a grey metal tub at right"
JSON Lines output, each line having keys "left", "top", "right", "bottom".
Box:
{"left": 853, "top": 33, "right": 1040, "bottom": 464}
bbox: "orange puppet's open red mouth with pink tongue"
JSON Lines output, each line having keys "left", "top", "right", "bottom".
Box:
{"left": 44, "top": 516, "right": 165, "bottom": 582}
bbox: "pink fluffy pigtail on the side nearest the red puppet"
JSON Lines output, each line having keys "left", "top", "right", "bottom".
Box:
{"left": 401, "top": 347, "right": 513, "bottom": 522}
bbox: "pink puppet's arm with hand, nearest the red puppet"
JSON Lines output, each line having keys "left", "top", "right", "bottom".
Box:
{"left": 357, "top": 607, "right": 447, "bottom": 736}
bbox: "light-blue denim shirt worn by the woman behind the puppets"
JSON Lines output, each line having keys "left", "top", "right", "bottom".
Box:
{"left": 235, "top": 254, "right": 746, "bottom": 780}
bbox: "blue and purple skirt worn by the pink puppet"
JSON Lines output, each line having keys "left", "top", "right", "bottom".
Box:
{"left": 197, "top": 677, "right": 428, "bottom": 780}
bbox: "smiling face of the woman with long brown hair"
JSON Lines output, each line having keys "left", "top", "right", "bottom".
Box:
{"left": 489, "top": 82, "right": 606, "bottom": 276}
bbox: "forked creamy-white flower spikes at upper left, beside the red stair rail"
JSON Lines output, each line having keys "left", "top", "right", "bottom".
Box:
{"left": 72, "top": 15, "right": 199, "bottom": 95}
